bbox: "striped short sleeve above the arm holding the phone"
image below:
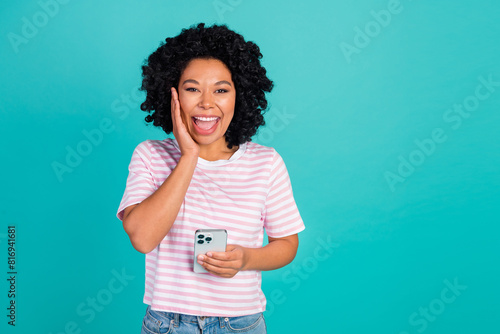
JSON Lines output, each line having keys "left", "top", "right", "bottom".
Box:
{"left": 264, "top": 151, "right": 305, "bottom": 238}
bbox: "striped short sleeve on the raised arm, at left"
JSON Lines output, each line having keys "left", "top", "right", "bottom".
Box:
{"left": 116, "top": 141, "right": 156, "bottom": 220}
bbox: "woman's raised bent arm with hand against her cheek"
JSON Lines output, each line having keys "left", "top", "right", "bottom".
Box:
{"left": 123, "top": 88, "right": 199, "bottom": 253}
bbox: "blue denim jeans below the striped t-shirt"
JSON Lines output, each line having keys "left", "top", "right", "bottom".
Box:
{"left": 141, "top": 306, "right": 267, "bottom": 334}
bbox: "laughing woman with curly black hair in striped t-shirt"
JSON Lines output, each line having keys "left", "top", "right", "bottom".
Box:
{"left": 117, "top": 24, "right": 304, "bottom": 333}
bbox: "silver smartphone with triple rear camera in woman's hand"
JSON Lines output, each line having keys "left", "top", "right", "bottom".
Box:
{"left": 193, "top": 229, "right": 227, "bottom": 273}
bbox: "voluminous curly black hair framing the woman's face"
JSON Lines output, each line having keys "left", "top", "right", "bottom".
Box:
{"left": 141, "top": 23, "right": 273, "bottom": 148}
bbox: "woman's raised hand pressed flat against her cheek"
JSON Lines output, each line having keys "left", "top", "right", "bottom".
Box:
{"left": 170, "top": 87, "right": 200, "bottom": 157}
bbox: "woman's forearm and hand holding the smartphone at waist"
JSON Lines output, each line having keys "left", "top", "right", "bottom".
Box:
{"left": 198, "top": 234, "right": 299, "bottom": 278}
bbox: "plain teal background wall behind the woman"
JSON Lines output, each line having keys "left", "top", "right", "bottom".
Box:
{"left": 0, "top": 0, "right": 500, "bottom": 334}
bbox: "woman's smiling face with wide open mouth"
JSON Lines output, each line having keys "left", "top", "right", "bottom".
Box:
{"left": 178, "top": 59, "right": 236, "bottom": 149}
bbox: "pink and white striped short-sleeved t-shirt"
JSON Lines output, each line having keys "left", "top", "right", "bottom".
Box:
{"left": 117, "top": 139, "right": 304, "bottom": 316}
